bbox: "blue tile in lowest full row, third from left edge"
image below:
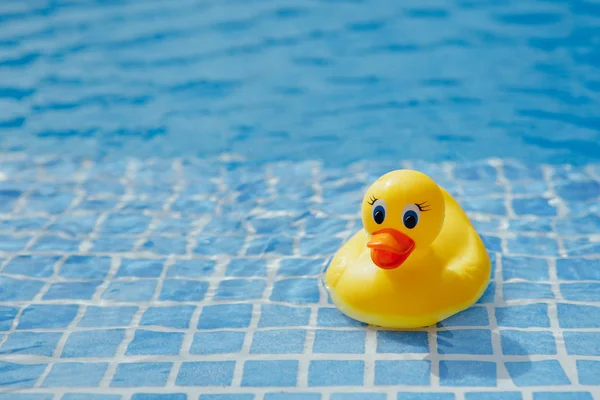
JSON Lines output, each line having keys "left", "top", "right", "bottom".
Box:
{"left": 110, "top": 362, "right": 173, "bottom": 387}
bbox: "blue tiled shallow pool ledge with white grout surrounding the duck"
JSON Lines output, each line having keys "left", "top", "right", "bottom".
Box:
{"left": 0, "top": 155, "right": 600, "bottom": 400}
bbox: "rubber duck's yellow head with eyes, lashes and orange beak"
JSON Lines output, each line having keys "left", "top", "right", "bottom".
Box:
{"left": 362, "top": 170, "right": 445, "bottom": 269}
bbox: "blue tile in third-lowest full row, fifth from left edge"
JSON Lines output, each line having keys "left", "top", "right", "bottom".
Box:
{"left": 198, "top": 304, "right": 252, "bottom": 329}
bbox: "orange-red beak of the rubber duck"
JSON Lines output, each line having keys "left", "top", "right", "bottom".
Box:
{"left": 367, "top": 229, "right": 415, "bottom": 269}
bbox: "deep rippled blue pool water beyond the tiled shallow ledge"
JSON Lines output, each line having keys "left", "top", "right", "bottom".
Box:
{"left": 0, "top": 0, "right": 600, "bottom": 165}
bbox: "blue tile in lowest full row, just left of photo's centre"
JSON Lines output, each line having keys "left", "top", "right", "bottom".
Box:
{"left": 242, "top": 360, "right": 298, "bottom": 387}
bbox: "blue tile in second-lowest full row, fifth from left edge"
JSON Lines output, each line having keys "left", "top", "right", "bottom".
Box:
{"left": 250, "top": 329, "right": 306, "bottom": 354}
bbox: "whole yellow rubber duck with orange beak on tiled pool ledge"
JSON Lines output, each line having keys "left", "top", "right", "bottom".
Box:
{"left": 325, "top": 170, "right": 491, "bottom": 329}
